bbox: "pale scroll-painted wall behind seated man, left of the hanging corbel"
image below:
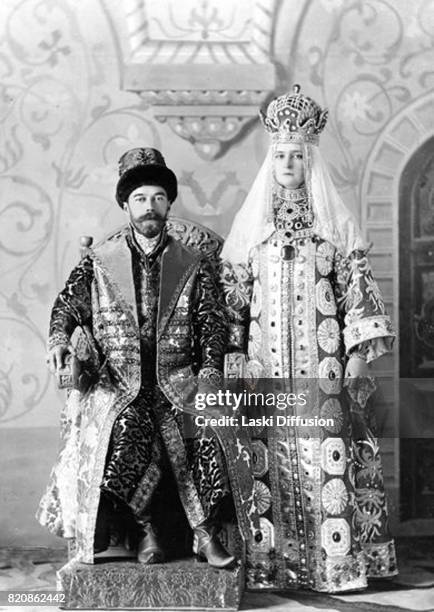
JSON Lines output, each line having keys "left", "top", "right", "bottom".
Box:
{"left": 0, "top": 0, "right": 268, "bottom": 427}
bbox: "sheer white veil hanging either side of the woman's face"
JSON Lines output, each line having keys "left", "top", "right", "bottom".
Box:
{"left": 221, "top": 143, "right": 367, "bottom": 264}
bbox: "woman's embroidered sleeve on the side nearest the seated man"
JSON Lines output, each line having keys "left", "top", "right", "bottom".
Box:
{"left": 220, "top": 260, "right": 253, "bottom": 353}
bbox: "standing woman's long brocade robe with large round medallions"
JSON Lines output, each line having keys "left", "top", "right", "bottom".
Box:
{"left": 223, "top": 233, "right": 396, "bottom": 592}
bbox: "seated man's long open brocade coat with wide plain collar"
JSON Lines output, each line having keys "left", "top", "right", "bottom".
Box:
{"left": 37, "top": 228, "right": 255, "bottom": 563}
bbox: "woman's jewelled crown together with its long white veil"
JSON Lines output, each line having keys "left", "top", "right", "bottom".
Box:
{"left": 221, "top": 85, "right": 367, "bottom": 264}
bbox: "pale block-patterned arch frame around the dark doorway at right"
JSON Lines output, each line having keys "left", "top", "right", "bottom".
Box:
{"left": 361, "top": 92, "right": 434, "bottom": 532}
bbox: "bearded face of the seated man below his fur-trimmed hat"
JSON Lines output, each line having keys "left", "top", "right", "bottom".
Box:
{"left": 123, "top": 185, "right": 170, "bottom": 238}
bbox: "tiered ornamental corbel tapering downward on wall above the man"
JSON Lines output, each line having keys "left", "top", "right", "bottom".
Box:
{"left": 123, "top": 0, "right": 276, "bottom": 161}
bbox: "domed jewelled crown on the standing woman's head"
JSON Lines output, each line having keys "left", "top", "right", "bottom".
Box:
{"left": 259, "top": 85, "right": 328, "bottom": 144}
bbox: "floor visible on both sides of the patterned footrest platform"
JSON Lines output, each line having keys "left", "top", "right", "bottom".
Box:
{"left": 0, "top": 538, "right": 434, "bottom": 612}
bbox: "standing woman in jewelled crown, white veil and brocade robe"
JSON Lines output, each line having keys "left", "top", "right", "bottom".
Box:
{"left": 222, "top": 86, "right": 396, "bottom": 592}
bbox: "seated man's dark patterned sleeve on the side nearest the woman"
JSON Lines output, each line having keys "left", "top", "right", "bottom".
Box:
{"left": 193, "top": 259, "right": 228, "bottom": 378}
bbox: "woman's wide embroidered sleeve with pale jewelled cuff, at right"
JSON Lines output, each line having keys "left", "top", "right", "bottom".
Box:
{"left": 335, "top": 250, "right": 395, "bottom": 362}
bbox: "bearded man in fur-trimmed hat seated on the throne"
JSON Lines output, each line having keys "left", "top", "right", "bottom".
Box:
{"left": 38, "top": 148, "right": 241, "bottom": 568}
